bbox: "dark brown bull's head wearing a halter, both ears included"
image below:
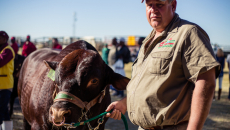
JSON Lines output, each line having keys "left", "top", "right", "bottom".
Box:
{"left": 44, "top": 49, "right": 129, "bottom": 127}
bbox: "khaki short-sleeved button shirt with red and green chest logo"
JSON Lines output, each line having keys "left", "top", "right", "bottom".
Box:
{"left": 127, "top": 14, "right": 220, "bottom": 128}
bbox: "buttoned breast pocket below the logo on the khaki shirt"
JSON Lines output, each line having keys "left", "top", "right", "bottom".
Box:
{"left": 148, "top": 51, "right": 173, "bottom": 75}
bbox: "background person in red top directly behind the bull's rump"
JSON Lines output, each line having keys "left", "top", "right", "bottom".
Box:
{"left": 22, "top": 35, "right": 37, "bottom": 57}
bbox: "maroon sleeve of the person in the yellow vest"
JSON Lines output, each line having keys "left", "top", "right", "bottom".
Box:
{"left": 0, "top": 49, "right": 14, "bottom": 67}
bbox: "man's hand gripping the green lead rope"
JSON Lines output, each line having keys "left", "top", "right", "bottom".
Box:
{"left": 106, "top": 97, "right": 127, "bottom": 120}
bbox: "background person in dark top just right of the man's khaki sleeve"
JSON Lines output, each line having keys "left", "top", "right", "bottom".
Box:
{"left": 213, "top": 48, "right": 225, "bottom": 100}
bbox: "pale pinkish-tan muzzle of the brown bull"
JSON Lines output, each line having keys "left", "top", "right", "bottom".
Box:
{"left": 50, "top": 107, "right": 71, "bottom": 126}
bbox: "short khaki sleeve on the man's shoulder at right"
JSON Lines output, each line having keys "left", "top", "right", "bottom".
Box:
{"left": 182, "top": 26, "right": 220, "bottom": 84}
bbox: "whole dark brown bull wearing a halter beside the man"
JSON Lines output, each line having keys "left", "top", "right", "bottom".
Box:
{"left": 18, "top": 41, "right": 129, "bottom": 130}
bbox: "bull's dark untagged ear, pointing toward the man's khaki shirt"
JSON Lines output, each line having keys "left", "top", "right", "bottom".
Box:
{"left": 106, "top": 66, "right": 130, "bottom": 90}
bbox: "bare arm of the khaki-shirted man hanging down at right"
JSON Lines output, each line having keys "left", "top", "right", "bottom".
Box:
{"left": 187, "top": 68, "right": 216, "bottom": 130}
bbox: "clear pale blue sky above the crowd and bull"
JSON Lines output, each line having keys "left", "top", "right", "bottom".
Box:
{"left": 0, "top": 0, "right": 230, "bottom": 45}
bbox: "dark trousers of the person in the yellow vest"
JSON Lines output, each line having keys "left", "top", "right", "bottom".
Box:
{"left": 0, "top": 89, "right": 11, "bottom": 124}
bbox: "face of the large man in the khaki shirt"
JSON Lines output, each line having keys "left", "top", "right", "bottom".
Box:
{"left": 145, "top": 0, "right": 176, "bottom": 32}
